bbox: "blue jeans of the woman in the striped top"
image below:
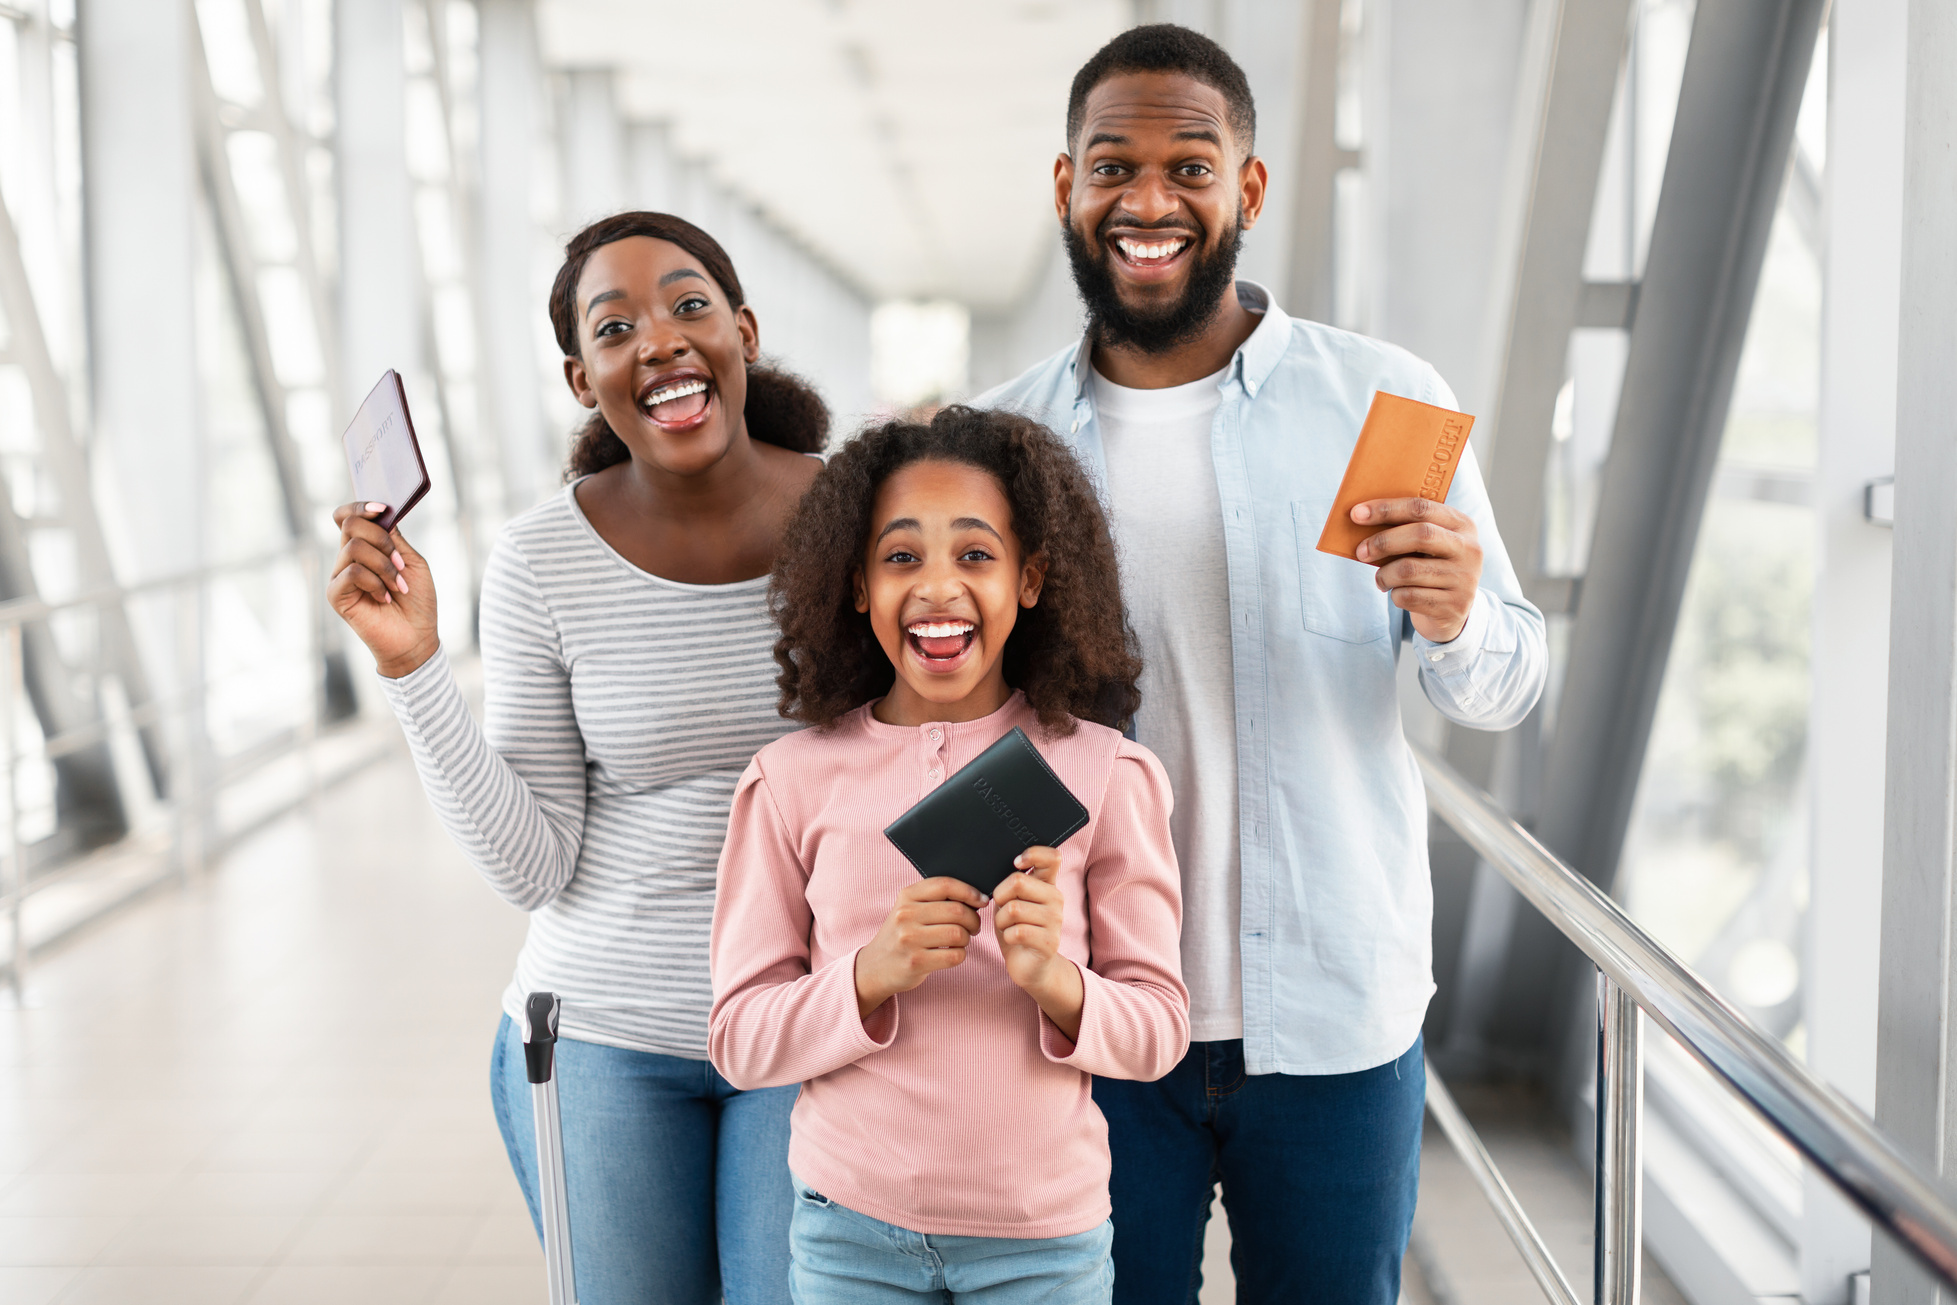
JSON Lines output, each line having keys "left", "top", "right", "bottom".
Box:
{"left": 489, "top": 1015, "right": 796, "bottom": 1305}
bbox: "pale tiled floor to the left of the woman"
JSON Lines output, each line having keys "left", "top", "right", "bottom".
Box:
{"left": 0, "top": 759, "right": 544, "bottom": 1305}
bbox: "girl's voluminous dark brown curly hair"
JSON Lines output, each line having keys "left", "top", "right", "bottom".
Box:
{"left": 767, "top": 407, "right": 1141, "bottom": 736}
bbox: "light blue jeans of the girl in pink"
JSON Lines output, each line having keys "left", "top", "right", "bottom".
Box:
{"left": 789, "top": 1182, "right": 1114, "bottom": 1305}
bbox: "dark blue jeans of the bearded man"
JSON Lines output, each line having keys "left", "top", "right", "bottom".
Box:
{"left": 1094, "top": 1039, "right": 1427, "bottom": 1305}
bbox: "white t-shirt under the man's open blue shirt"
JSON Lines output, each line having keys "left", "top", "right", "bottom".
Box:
{"left": 1094, "top": 368, "right": 1243, "bottom": 1043}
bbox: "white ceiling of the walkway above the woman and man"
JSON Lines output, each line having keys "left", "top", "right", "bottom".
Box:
{"left": 540, "top": 0, "right": 1133, "bottom": 309}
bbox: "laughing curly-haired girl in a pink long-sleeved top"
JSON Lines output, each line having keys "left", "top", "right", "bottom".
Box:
{"left": 708, "top": 407, "right": 1188, "bottom": 1305}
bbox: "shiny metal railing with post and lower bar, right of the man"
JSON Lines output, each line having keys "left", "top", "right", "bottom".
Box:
{"left": 1415, "top": 747, "right": 1957, "bottom": 1305}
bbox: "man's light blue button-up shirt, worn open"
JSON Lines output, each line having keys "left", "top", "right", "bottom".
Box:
{"left": 975, "top": 282, "right": 1548, "bottom": 1074}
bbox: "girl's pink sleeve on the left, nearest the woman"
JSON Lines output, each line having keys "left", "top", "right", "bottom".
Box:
{"left": 706, "top": 761, "right": 898, "bottom": 1092}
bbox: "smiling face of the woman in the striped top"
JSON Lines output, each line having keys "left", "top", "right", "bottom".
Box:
{"left": 564, "top": 235, "right": 759, "bottom": 475}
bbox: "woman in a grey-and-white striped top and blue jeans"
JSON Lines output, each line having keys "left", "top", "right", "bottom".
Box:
{"left": 327, "top": 213, "right": 828, "bottom": 1305}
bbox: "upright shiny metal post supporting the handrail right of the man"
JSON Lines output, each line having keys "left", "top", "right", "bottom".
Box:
{"left": 1595, "top": 970, "right": 1644, "bottom": 1305}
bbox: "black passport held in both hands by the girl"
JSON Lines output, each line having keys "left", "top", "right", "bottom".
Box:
{"left": 883, "top": 726, "right": 1088, "bottom": 896}
